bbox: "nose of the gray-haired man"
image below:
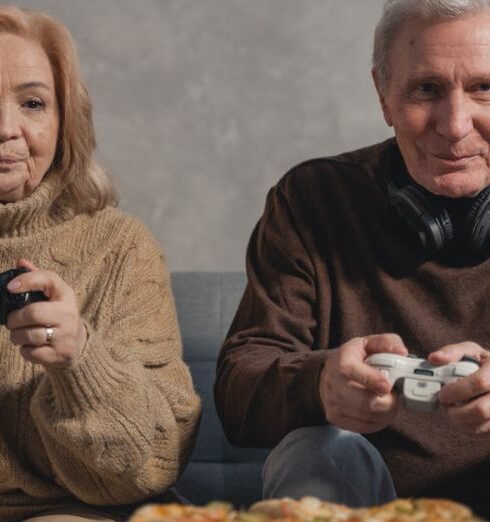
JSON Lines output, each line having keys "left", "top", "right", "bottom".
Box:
{"left": 436, "top": 92, "right": 473, "bottom": 141}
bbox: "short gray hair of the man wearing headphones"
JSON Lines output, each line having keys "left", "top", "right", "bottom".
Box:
{"left": 373, "top": 0, "right": 490, "bottom": 90}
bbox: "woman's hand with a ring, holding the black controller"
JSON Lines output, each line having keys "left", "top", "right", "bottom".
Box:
{"left": 6, "top": 259, "right": 87, "bottom": 368}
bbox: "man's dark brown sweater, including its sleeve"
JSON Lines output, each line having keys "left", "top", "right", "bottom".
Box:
{"left": 215, "top": 140, "right": 490, "bottom": 516}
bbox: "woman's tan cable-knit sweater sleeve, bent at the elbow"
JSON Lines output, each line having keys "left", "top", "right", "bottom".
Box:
{"left": 31, "top": 222, "right": 200, "bottom": 505}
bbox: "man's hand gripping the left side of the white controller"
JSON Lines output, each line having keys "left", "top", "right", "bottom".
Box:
{"left": 320, "top": 334, "right": 408, "bottom": 433}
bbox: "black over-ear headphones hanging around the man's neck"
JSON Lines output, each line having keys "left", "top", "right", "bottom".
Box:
{"left": 383, "top": 170, "right": 490, "bottom": 255}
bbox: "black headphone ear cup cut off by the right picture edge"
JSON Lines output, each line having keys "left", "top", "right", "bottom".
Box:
{"left": 464, "top": 186, "right": 490, "bottom": 253}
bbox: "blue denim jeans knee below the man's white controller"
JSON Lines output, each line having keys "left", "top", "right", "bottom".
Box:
{"left": 262, "top": 426, "right": 396, "bottom": 507}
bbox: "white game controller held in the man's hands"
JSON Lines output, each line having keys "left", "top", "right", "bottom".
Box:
{"left": 365, "top": 353, "right": 480, "bottom": 412}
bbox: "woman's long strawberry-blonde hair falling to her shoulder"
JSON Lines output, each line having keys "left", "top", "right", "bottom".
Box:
{"left": 0, "top": 6, "right": 117, "bottom": 213}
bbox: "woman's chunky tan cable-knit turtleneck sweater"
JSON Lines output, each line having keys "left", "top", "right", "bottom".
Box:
{"left": 0, "top": 173, "right": 200, "bottom": 522}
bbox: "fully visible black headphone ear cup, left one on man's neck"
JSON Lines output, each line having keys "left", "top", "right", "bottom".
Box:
{"left": 388, "top": 183, "right": 454, "bottom": 253}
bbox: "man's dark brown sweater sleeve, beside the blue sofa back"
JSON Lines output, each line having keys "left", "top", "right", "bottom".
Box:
{"left": 215, "top": 180, "right": 326, "bottom": 447}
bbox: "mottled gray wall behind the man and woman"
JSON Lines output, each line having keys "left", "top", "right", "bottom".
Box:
{"left": 15, "top": 0, "right": 390, "bottom": 270}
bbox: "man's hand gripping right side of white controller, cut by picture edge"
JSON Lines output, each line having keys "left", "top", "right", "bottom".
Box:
{"left": 428, "top": 342, "right": 490, "bottom": 437}
